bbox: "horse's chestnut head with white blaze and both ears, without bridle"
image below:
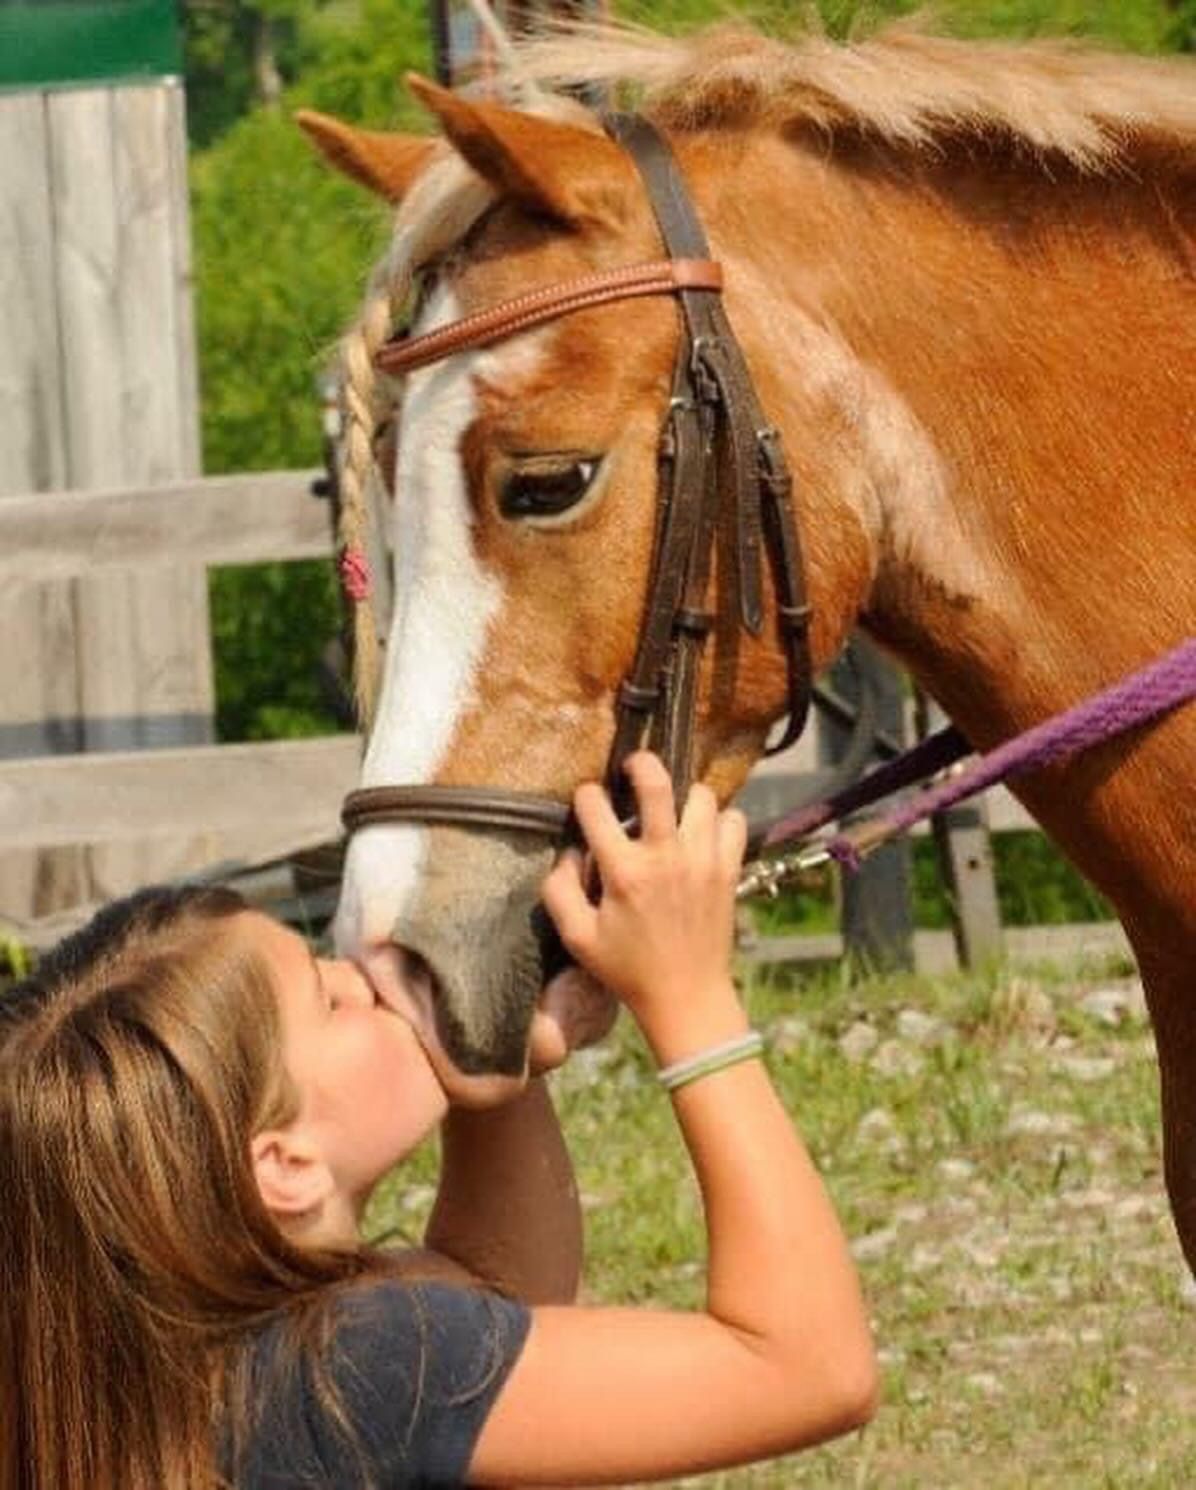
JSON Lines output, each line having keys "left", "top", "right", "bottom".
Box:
{"left": 301, "top": 80, "right": 864, "bottom": 1108}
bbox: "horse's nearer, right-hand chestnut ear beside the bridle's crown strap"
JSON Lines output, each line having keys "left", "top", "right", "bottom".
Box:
{"left": 407, "top": 73, "right": 630, "bottom": 225}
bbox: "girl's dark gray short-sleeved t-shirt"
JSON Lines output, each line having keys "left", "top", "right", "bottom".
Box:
{"left": 234, "top": 1280, "right": 530, "bottom": 1490}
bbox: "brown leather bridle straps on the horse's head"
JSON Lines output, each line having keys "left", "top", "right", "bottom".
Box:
{"left": 341, "top": 115, "right": 810, "bottom": 839}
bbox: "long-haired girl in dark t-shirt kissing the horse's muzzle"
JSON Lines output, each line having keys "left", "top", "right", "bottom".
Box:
{"left": 0, "top": 754, "right": 876, "bottom": 1490}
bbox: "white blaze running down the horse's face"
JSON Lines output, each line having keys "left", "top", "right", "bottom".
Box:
{"left": 337, "top": 289, "right": 502, "bottom": 951}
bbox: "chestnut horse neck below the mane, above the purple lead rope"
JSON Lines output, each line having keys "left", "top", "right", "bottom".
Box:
{"left": 697, "top": 136, "right": 1196, "bottom": 744}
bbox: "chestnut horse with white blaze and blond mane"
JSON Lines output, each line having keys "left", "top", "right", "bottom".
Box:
{"left": 296, "top": 23, "right": 1196, "bottom": 1265}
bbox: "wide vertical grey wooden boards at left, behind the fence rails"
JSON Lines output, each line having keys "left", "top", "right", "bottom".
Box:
{"left": 0, "top": 79, "right": 211, "bottom": 918}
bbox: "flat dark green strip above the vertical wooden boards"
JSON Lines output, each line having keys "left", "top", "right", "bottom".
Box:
{"left": 0, "top": 0, "right": 182, "bottom": 88}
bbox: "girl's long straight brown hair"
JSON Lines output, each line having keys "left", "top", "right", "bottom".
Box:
{"left": 0, "top": 888, "right": 378, "bottom": 1490}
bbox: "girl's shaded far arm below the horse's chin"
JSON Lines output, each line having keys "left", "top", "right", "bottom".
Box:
{"left": 424, "top": 1076, "right": 582, "bottom": 1304}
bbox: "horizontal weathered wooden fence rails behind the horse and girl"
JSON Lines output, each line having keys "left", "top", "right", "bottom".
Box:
{"left": 0, "top": 471, "right": 1131, "bottom": 963}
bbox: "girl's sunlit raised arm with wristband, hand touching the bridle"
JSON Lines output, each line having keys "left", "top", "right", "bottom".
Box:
{"left": 469, "top": 755, "right": 877, "bottom": 1486}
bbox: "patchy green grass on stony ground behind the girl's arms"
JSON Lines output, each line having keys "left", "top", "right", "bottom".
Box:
{"left": 372, "top": 969, "right": 1196, "bottom": 1490}
